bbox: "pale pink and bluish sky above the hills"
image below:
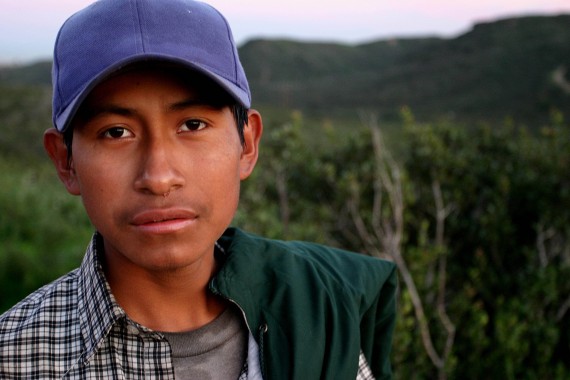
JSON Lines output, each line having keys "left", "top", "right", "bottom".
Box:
{"left": 0, "top": 0, "right": 570, "bottom": 64}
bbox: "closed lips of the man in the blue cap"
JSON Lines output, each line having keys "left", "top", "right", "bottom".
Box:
{"left": 131, "top": 209, "right": 198, "bottom": 234}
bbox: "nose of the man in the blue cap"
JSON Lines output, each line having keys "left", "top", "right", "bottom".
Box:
{"left": 135, "top": 137, "right": 184, "bottom": 196}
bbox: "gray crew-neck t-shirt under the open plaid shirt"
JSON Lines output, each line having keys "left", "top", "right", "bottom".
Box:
{"left": 163, "top": 306, "right": 248, "bottom": 380}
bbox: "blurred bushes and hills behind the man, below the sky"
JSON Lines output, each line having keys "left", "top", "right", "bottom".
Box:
{"left": 0, "top": 12, "right": 570, "bottom": 379}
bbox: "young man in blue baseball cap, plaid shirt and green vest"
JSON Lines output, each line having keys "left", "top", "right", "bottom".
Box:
{"left": 0, "top": 0, "right": 396, "bottom": 379}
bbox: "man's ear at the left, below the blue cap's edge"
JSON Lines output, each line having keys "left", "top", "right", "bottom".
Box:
{"left": 44, "top": 128, "right": 81, "bottom": 195}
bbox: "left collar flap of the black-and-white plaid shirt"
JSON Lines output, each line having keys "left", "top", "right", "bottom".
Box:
{"left": 78, "top": 233, "right": 126, "bottom": 361}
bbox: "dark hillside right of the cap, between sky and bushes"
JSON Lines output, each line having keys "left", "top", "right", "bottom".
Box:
{"left": 240, "top": 15, "right": 570, "bottom": 122}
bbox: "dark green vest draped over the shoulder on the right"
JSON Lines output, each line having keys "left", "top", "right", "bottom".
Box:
{"left": 210, "top": 228, "right": 397, "bottom": 380}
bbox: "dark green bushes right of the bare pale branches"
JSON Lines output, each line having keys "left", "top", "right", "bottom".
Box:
{"left": 405, "top": 114, "right": 570, "bottom": 379}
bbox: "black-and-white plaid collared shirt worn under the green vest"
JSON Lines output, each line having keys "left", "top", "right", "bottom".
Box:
{"left": 0, "top": 234, "right": 374, "bottom": 380}
